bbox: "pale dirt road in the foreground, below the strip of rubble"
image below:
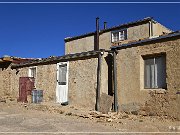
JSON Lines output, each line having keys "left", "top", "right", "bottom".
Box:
{"left": 0, "top": 100, "right": 180, "bottom": 135}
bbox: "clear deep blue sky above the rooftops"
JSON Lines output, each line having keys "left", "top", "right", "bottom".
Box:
{"left": 0, "top": 0, "right": 180, "bottom": 58}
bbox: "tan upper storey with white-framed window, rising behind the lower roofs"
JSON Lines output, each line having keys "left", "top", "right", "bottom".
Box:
{"left": 64, "top": 17, "right": 172, "bottom": 54}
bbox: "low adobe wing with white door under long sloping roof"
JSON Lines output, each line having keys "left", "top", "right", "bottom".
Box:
{"left": 11, "top": 50, "right": 108, "bottom": 109}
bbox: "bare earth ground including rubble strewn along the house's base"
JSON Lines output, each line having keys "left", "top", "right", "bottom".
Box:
{"left": 0, "top": 98, "right": 180, "bottom": 135}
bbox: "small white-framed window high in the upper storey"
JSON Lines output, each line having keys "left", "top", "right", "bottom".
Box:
{"left": 111, "top": 29, "right": 127, "bottom": 42}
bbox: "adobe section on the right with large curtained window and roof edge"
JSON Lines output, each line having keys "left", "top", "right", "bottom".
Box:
{"left": 111, "top": 31, "right": 180, "bottom": 119}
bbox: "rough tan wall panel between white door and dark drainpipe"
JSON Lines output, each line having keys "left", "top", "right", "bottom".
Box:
{"left": 68, "top": 58, "right": 98, "bottom": 109}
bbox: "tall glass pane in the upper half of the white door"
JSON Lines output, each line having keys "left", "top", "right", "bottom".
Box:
{"left": 58, "top": 64, "right": 67, "bottom": 85}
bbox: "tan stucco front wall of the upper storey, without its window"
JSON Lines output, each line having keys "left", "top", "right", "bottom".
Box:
{"left": 65, "top": 23, "right": 149, "bottom": 54}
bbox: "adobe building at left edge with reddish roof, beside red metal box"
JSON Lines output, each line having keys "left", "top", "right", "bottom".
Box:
{"left": 0, "top": 55, "right": 32, "bottom": 98}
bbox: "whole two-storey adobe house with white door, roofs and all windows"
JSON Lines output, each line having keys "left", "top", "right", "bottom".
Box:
{"left": 3, "top": 17, "right": 180, "bottom": 117}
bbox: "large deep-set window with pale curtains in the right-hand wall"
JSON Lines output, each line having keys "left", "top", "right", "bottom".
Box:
{"left": 144, "top": 55, "right": 166, "bottom": 89}
